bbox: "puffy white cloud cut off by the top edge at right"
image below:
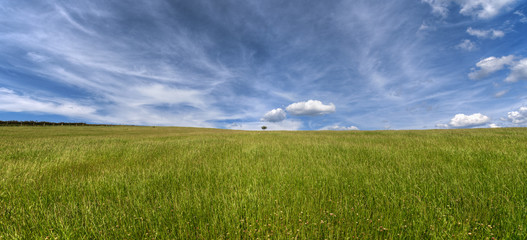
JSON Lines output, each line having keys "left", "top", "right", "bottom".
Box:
{"left": 422, "top": 0, "right": 517, "bottom": 19}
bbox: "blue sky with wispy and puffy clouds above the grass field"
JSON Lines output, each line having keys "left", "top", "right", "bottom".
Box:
{"left": 0, "top": 0, "right": 527, "bottom": 130}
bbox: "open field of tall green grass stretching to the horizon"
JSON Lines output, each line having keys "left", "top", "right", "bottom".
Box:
{"left": 0, "top": 126, "right": 527, "bottom": 239}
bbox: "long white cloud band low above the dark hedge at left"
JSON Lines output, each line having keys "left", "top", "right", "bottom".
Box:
{"left": 0, "top": 88, "right": 96, "bottom": 117}
